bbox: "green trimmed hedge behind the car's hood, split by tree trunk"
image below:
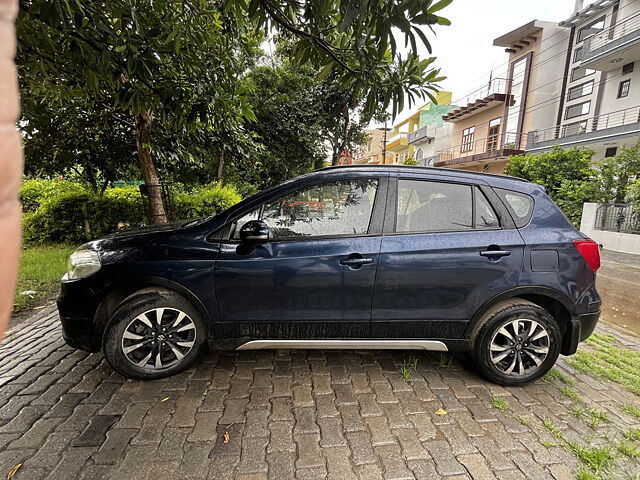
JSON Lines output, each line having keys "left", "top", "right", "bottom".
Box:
{"left": 20, "top": 180, "right": 241, "bottom": 244}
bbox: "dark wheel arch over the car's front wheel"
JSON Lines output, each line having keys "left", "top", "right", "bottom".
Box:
{"left": 94, "top": 276, "right": 212, "bottom": 342}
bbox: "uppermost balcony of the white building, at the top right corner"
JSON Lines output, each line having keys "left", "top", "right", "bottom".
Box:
{"left": 580, "top": 13, "right": 640, "bottom": 72}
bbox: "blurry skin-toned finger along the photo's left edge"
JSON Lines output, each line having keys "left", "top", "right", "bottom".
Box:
{"left": 0, "top": 0, "right": 22, "bottom": 340}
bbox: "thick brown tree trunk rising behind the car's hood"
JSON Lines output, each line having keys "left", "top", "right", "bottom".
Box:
{"left": 136, "top": 112, "right": 167, "bottom": 223}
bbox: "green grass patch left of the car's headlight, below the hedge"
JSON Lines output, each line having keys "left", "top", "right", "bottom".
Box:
{"left": 13, "top": 245, "right": 74, "bottom": 311}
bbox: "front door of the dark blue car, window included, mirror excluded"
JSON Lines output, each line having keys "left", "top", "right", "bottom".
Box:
{"left": 214, "top": 176, "right": 387, "bottom": 339}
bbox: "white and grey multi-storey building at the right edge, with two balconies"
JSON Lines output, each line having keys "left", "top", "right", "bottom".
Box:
{"left": 526, "top": 0, "right": 640, "bottom": 160}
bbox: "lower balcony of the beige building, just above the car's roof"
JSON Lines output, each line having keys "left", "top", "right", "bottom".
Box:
{"left": 430, "top": 132, "right": 527, "bottom": 167}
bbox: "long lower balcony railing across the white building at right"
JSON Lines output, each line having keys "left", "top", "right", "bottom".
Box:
{"left": 529, "top": 106, "right": 640, "bottom": 146}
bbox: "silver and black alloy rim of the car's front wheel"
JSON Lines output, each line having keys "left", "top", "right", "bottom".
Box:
{"left": 122, "top": 307, "right": 196, "bottom": 370}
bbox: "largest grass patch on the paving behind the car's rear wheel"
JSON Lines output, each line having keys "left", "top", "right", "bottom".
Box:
{"left": 567, "top": 332, "right": 640, "bottom": 395}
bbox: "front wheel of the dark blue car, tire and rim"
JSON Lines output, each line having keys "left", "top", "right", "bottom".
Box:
{"left": 102, "top": 289, "right": 207, "bottom": 380}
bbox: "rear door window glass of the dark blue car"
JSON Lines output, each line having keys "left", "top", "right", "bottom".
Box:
{"left": 396, "top": 179, "right": 500, "bottom": 233}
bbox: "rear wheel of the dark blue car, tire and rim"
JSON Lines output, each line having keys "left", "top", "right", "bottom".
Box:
{"left": 471, "top": 298, "right": 562, "bottom": 386}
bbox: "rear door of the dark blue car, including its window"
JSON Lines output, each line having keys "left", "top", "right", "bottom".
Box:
{"left": 372, "top": 176, "right": 523, "bottom": 339}
